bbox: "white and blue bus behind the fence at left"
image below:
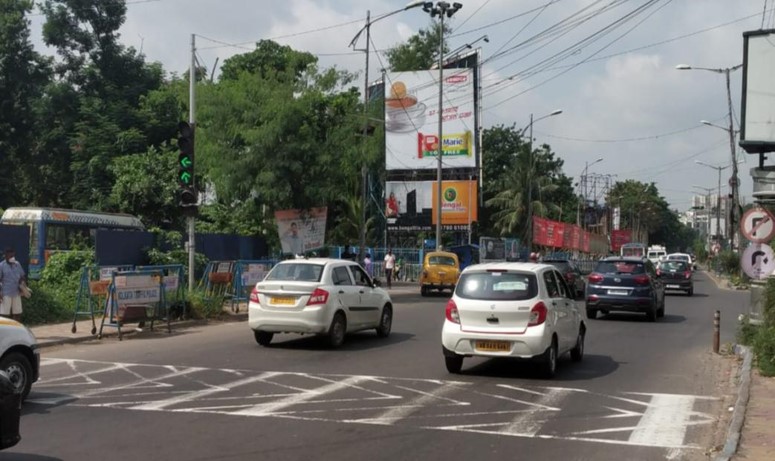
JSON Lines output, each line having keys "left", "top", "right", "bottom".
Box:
{"left": 0, "top": 207, "right": 145, "bottom": 279}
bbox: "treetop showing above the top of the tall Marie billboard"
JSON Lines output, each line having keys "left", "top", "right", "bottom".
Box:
{"left": 387, "top": 21, "right": 452, "bottom": 72}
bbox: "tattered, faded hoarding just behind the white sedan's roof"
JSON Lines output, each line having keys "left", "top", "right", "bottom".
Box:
{"left": 274, "top": 207, "right": 328, "bottom": 255}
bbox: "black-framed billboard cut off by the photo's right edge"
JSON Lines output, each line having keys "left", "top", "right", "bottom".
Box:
{"left": 740, "top": 29, "right": 775, "bottom": 154}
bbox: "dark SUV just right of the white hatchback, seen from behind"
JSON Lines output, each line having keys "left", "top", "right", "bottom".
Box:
{"left": 586, "top": 256, "right": 665, "bottom": 322}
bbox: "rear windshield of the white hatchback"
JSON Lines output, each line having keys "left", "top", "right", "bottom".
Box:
{"left": 455, "top": 271, "right": 538, "bottom": 301}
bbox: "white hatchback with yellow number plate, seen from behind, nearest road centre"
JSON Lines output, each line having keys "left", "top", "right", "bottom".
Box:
{"left": 441, "top": 263, "right": 587, "bottom": 378}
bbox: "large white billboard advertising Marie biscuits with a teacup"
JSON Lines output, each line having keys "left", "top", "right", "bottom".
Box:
{"left": 385, "top": 69, "right": 477, "bottom": 171}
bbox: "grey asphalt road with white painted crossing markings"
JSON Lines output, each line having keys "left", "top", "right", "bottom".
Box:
{"left": 0, "top": 274, "right": 747, "bottom": 461}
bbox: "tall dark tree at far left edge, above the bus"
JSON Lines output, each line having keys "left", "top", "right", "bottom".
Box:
{"left": 0, "top": 0, "right": 50, "bottom": 208}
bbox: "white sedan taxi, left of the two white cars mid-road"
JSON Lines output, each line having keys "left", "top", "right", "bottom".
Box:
{"left": 248, "top": 258, "right": 393, "bottom": 347}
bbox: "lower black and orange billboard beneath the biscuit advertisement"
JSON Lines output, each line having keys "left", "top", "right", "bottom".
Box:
{"left": 385, "top": 180, "right": 479, "bottom": 230}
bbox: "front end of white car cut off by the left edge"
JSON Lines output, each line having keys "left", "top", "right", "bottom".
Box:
{"left": 0, "top": 317, "right": 40, "bottom": 400}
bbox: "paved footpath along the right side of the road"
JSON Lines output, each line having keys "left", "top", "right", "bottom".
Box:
{"left": 705, "top": 271, "right": 775, "bottom": 461}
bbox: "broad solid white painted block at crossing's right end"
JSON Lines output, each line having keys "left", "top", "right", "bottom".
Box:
{"left": 629, "top": 394, "right": 695, "bottom": 447}
